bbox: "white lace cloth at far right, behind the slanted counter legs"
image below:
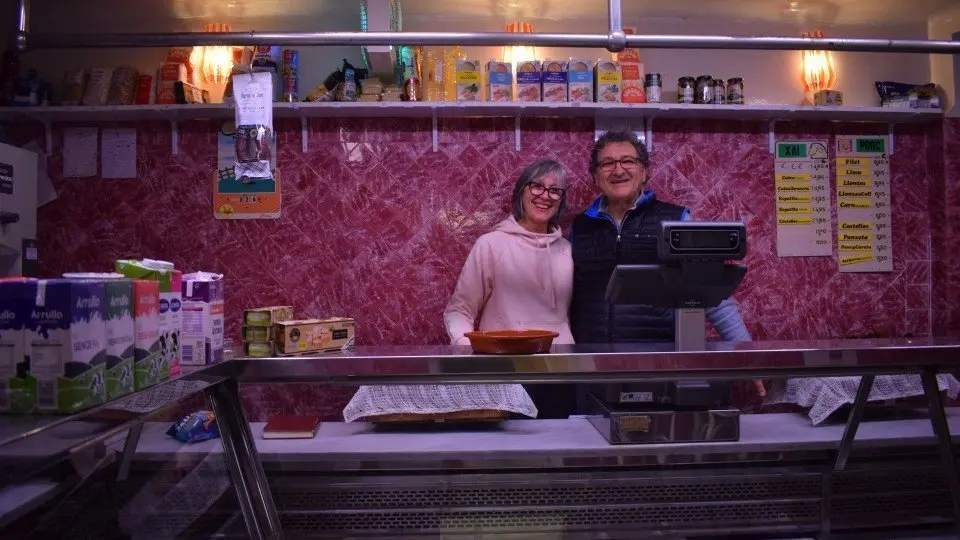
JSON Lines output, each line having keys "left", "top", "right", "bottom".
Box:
{"left": 763, "top": 374, "right": 960, "bottom": 425}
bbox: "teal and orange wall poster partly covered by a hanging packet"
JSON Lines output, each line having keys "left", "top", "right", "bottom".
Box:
{"left": 213, "top": 122, "right": 280, "bottom": 219}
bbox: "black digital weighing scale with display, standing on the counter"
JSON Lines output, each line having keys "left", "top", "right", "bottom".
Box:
{"left": 588, "top": 221, "right": 747, "bottom": 444}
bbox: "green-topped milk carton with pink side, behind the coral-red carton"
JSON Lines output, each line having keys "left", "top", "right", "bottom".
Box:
{"left": 116, "top": 259, "right": 183, "bottom": 377}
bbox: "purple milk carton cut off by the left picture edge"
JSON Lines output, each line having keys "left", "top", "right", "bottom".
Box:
{"left": 0, "top": 279, "right": 37, "bottom": 414}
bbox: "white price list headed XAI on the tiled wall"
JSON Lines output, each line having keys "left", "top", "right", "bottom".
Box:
{"left": 773, "top": 141, "right": 833, "bottom": 257}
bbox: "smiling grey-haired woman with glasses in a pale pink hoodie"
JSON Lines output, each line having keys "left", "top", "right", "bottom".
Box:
{"left": 443, "top": 160, "right": 573, "bottom": 345}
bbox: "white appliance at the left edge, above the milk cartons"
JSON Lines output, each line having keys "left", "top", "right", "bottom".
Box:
{"left": 0, "top": 144, "right": 38, "bottom": 278}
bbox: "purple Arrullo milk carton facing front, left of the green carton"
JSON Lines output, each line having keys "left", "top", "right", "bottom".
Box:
{"left": 24, "top": 279, "right": 107, "bottom": 413}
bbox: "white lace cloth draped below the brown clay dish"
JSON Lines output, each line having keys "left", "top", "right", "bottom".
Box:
{"left": 343, "top": 384, "right": 537, "bottom": 422}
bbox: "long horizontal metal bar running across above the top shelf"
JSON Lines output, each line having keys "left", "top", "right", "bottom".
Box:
{"left": 20, "top": 32, "right": 960, "bottom": 54}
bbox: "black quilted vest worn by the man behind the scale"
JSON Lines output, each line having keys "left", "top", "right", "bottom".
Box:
{"left": 570, "top": 197, "right": 684, "bottom": 343}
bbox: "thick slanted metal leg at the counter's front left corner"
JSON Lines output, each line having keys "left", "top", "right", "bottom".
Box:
{"left": 207, "top": 379, "right": 283, "bottom": 539}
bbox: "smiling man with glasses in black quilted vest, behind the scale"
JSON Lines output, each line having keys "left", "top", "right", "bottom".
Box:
{"left": 570, "top": 131, "right": 759, "bottom": 344}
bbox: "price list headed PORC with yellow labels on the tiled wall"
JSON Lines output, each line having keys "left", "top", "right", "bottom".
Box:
{"left": 837, "top": 136, "right": 893, "bottom": 272}
